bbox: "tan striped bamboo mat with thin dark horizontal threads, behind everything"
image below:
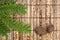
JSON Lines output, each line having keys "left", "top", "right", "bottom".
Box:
{"left": 0, "top": 0, "right": 60, "bottom": 40}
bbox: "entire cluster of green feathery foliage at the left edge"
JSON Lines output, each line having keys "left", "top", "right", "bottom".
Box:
{"left": 0, "top": 0, "right": 30, "bottom": 36}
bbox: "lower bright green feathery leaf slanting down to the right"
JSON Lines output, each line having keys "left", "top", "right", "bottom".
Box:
{"left": 0, "top": 14, "right": 30, "bottom": 32}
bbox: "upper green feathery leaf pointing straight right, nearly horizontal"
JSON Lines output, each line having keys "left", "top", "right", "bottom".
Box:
{"left": 0, "top": 4, "right": 27, "bottom": 14}
